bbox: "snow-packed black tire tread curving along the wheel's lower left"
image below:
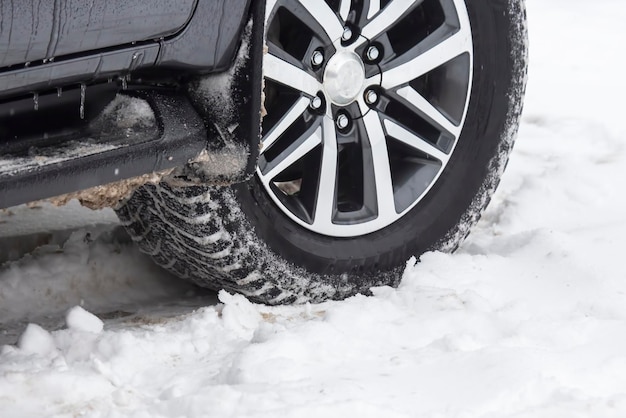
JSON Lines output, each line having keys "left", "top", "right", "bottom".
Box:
{"left": 117, "top": 183, "right": 401, "bottom": 304}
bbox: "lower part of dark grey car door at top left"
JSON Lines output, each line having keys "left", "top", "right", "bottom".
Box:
{"left": 0, "top": 0, "right": 197, "bottom": 68}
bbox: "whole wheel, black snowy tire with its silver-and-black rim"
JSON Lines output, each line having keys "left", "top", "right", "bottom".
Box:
{"left": 117, "top": 0, "right": 527, "bottom": 304}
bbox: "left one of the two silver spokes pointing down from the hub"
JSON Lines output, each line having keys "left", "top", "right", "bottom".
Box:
{"left": 313, "top": 118, "right": 337, "bottom": 227}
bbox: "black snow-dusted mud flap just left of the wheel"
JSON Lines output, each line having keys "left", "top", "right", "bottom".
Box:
{"left": 183, "top": 1, "right": 265, "bottom": 184}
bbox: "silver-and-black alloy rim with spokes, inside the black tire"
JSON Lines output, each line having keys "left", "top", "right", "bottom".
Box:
{"left": 257, "top": 0, "right": 473, "bottom": 237}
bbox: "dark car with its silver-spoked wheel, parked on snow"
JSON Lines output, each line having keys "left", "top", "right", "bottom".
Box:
{"left": 0, "top": 0, "right": 527, "bottom": 304}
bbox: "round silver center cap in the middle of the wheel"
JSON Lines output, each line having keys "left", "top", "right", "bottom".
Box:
{"left": 324, "top": 51, "right": 365, "bottom": 106}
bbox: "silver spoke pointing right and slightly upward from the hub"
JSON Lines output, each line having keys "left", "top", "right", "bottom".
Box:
{"left": 382, "top": 29, "right": 472, "bottom": 89}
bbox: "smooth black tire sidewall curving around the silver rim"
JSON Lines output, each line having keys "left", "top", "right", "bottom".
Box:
{"left": 233, "top": 0, "right": 523, "bottom": 274}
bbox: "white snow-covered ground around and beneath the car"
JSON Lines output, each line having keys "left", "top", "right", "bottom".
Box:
{"left": 0, "top": 0, "right": 626, "bottom": 418}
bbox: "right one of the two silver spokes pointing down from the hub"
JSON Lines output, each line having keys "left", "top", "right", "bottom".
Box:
{"left": 363, "top": 112, "right": 396, "bottom": 222}
